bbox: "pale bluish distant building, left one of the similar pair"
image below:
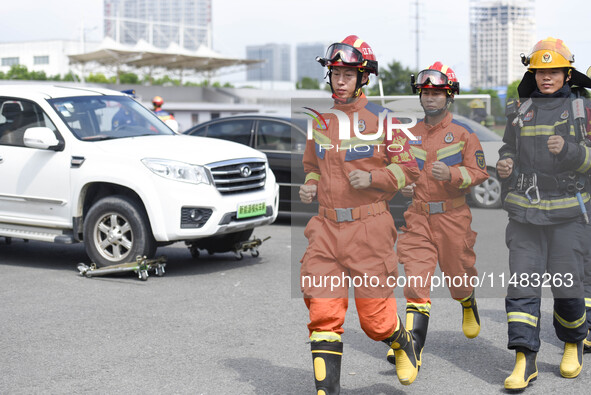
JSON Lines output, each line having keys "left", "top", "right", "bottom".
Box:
{"left": 246, "top": 44, "right": 291, "bottom": 81}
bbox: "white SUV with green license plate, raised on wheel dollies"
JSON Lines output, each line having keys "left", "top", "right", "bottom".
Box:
{"left": 0, "top": 85, "right": 279, "bottom": 266}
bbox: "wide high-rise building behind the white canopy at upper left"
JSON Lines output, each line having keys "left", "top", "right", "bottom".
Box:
{"left": 104, "top": 0, "right": 212, "bottom": 50}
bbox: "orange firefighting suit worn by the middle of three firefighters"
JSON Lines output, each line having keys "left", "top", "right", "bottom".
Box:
{"left": 397, "top": 113, "right": 488, "bottom": 312}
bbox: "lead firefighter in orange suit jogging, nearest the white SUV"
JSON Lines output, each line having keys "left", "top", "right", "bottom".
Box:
{"left": 300, "top": 36, "right": 419, "bottom": 394}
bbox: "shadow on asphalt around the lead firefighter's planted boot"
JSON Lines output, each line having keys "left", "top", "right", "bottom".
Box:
{"left": 224, "top": 358, "right": 404, "bottom": 395}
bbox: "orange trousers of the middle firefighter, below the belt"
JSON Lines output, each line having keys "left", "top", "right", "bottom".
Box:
{"left": 397, "top": 205, "right": 478, "bottom": 304}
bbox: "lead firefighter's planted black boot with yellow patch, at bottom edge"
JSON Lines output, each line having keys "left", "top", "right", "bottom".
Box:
{"left": 311, "top": 341, "right": 343, "bottom": 395}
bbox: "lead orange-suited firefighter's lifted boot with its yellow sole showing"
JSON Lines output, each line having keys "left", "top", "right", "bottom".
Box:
{"left": 384, "top": 317, "right": 419, "bottom": 385}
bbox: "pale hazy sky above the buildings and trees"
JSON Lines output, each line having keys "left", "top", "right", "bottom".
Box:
{"left": 0, "top": 0, "right": 591, "bottom": 86}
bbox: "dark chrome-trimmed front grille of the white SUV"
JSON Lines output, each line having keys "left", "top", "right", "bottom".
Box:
{"left": 207, "top": 158, "right": 267, "bottom": 195}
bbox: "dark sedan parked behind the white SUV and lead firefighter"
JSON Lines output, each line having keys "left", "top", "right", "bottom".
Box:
{"left": 183, "top": 115, "right": 410, "bottom": 225}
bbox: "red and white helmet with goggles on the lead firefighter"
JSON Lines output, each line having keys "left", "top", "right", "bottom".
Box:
{"left": 316, "top": 35, "right": 378, "bottom": 75}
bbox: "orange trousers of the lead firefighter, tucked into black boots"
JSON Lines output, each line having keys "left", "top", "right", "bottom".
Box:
{"left": 300, "top": 212, "right": 398, "bottom": 341}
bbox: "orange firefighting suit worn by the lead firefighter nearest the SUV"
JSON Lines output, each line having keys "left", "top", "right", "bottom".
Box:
{"left": 301, "top": 94, "right": 419, "bottom": 341}
